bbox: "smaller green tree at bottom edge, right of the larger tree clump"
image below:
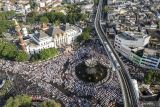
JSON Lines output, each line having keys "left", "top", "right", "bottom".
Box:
{"left": 40, "top": 100, "right": 61, "bottom": 107}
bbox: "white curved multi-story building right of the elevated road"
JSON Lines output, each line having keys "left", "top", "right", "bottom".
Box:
{"left": 114, "top": 31, "right": 160, "bottom": 69}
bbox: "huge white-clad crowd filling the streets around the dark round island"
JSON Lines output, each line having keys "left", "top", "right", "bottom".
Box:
{"left": 0, "top": 41, "right": 122, "bottom": 107}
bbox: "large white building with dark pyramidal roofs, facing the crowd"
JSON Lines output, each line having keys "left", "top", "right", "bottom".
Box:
{"left": 23, "top": 24, "right": 82, "bottom": 54}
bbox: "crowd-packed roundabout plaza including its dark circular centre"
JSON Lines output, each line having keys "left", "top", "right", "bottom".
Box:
{"left": 2, "top": 46, "right": 121, "bottom": 107}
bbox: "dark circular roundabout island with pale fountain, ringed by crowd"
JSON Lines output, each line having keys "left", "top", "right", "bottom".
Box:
{"left": 75, "top": 58, "right": 108, "bottom": 83}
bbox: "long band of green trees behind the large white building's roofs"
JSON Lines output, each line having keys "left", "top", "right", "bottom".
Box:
{"left": 26, "top": 5, "right": 87, "bottom": 24}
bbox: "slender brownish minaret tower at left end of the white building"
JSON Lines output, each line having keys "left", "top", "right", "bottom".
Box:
{"left": 14, "top": 19, "right": 26, "bottom": 51}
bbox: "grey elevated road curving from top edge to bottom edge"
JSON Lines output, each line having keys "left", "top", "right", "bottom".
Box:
{"left": 95, "top": 0, "right": 138, "bottom": 107}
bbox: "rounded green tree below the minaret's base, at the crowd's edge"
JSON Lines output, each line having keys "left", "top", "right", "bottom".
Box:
{"left": 15, "top": 51, "right": 29, "bottom": 62}
